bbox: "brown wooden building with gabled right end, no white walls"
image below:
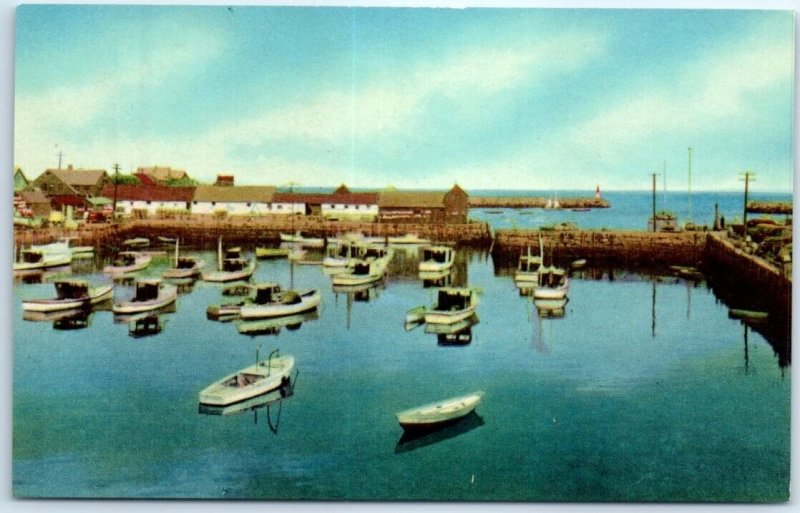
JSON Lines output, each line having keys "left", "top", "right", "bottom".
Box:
{"left": 378, "top": 185, "right": 469, "bottom": 223}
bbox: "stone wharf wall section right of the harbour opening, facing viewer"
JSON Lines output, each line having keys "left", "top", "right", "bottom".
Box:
{"left": 492, "top": 230, "right": 707, "bottom": 266}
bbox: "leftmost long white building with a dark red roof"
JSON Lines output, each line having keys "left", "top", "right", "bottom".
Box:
{"left": 102, "top": 184, "right": 195, "bottom": 216}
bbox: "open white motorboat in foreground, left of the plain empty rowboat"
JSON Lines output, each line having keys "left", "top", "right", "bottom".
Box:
{"left": 199, "top": 350, "right": 294, "bottom": 406}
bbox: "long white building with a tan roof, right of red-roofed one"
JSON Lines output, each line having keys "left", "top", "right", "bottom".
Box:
{"left": 191, "top": 185, "right": 275, "bottom": 215}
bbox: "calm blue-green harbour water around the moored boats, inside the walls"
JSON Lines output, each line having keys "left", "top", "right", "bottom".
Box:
{"left": 12, "top": 243, "right": 791, "bottom": 501}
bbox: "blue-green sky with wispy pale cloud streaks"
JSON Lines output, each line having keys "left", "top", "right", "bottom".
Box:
{"left": 14, "top": 5, "right": 794, "bottom": 191}
